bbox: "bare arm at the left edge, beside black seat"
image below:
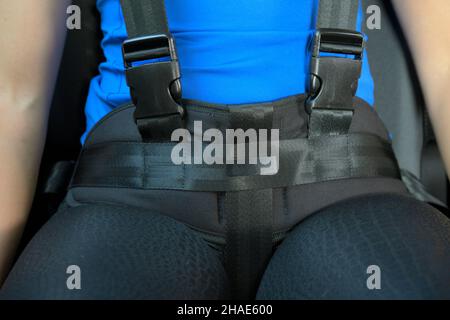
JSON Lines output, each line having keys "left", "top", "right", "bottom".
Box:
{"left": 0, "top": 0, "right": 70, "bottom": 285}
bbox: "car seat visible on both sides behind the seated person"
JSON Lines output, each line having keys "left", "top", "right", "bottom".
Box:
{"left": 19, "top": 0, "right": 448, "bottom": 249}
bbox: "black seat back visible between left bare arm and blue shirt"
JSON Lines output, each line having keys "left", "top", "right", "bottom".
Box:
{"left": 23, "top": 0, "right": 103, "bottom": 244}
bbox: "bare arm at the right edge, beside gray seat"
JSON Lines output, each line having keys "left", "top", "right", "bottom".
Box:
{"left": 393, "top": 0, "right": 450, "bottom": 173}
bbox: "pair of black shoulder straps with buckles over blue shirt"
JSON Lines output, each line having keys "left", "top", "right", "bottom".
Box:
{"left": 121, "top": 0, "right": 364, "bottom": 141}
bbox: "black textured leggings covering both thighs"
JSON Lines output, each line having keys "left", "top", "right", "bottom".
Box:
{"left": 1, "top": 195, "right": 450, "bottom": 299}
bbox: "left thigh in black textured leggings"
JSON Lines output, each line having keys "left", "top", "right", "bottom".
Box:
{"left": 1, "top": 205, "right": 228, "bottom": 299}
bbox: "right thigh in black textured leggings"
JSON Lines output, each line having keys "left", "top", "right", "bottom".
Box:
{"left": 258, "top": 195, "right": 450, "bottom": 299}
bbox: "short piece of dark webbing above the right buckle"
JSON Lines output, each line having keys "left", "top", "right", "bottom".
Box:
{"left": 316, "top": 0, "right": 359, "bottom": 30}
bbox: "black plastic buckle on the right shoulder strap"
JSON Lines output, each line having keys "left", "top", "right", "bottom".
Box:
{"left": 306, "top": 29, "right": 365, "bottom": 114}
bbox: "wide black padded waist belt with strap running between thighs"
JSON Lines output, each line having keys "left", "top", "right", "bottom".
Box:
{"left": 71, "top": 96, "right": 405, "bottom": 298}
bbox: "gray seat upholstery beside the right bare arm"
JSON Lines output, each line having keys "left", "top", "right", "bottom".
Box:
{"left": 362, "top": 0, "right": 447, "bottom": 202}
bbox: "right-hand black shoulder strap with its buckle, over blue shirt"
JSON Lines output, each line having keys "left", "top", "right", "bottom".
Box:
{"left": 307, "top": 0, "right": 364, "bottom": 136}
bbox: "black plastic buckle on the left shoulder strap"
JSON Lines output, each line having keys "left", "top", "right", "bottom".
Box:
{"left": 123, "top": 34, "right": 184, "bottom": 136}
